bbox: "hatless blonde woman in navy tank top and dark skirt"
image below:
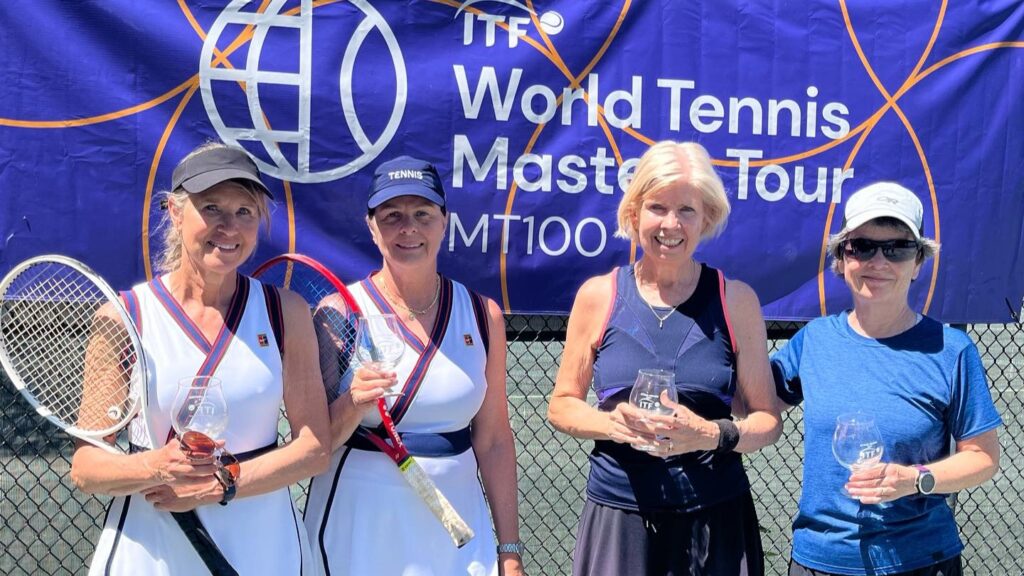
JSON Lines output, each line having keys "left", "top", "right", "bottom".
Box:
{"left": 548, "top": 141, "right": 781, "bottom": 576}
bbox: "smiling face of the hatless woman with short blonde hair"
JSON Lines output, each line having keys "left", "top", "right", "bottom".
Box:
{"left": 633, "top": 180, "right": 707, "bottom": 260}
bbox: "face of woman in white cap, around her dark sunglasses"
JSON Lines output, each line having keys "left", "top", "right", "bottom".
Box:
{"left": 839, "top": 220, "right": 922, "bottom": 306}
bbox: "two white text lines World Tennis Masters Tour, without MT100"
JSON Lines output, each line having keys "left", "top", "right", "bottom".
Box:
{"left": 452, "top": 65, "right": 853, "bottom": 204}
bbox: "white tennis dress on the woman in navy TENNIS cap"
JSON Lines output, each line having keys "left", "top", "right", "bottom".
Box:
{"left": 305, "top": 279, "right": 498, "bottom": 576}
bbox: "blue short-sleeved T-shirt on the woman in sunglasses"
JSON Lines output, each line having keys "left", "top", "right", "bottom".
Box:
{"left": 772, "top": 313, "right": 1001, "bottom": 575}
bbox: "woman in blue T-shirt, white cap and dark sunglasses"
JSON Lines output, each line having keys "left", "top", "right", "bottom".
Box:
{"left": 772, "top": 182, "right": 1001, "bottom": 576}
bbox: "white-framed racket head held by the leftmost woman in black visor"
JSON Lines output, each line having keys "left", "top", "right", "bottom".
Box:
{"left": 0, "top": 255, "right": 156, "bottom": 454}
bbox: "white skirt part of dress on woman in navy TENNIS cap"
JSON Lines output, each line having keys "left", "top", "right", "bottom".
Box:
{"left": 305, "top": 448, "right": 498, "bottom": 576}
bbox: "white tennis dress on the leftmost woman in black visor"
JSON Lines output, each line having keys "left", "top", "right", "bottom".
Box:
{"left": 89, "top": 276, "right": 314, "bottom": 576}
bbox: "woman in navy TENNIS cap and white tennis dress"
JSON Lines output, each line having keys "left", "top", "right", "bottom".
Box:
{"left": 305, "top": 156, "right": 523, "bottom": 576}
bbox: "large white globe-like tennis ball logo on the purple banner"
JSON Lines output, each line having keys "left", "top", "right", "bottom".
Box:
{"left": 200, "top": 0, "right": 408, "bottom": 182}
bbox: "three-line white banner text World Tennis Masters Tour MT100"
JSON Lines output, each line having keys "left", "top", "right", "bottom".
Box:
{"left": 449, "top": 65, "right": 854, "bottom": 257}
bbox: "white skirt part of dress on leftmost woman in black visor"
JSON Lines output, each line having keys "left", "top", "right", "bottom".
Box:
{"left": 89, "top": 488, "right": 315, "bottom": 576}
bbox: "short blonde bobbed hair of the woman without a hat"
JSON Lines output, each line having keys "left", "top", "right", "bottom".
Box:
{"left": 615, "top": 140, "right": 731, "bottom": 241}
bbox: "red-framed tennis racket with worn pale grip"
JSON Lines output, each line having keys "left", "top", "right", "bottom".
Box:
{"left": 253, "top": 254, "right": 473, "bottom": 548}
